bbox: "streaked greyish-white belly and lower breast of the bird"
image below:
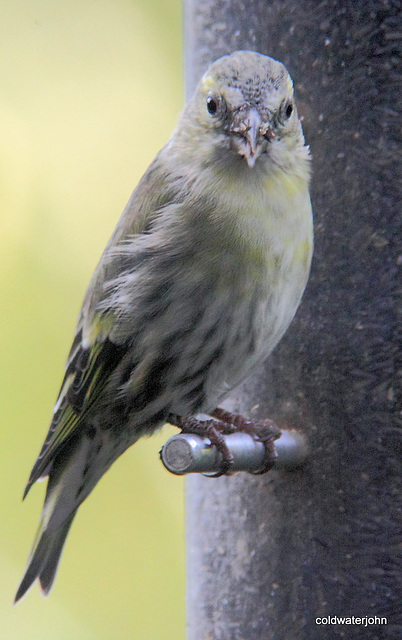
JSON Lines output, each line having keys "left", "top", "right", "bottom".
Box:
{"left": 119, "top": 193, "right": 312, "bottom": 422}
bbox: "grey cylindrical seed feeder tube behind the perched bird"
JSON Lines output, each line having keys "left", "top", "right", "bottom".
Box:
{"left": 184, "top": 0, "right": 401, "bottom": 640}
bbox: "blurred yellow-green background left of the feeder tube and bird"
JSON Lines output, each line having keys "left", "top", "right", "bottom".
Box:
{"left": 0, "top": 0, "right": 185, "bottom": 640}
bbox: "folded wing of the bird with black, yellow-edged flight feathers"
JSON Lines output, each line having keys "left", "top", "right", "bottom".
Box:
{"left": 24, "top": 156, "right": 172, "bottom": 498}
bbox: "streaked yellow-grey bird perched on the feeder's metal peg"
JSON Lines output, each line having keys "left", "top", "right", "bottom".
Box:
{"left": 15, "top": 50, "right": 313, "bottom": 602}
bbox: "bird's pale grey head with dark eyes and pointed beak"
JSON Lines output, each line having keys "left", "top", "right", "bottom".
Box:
{"left": 185, "top": 51, "right": 304, "bottom": 168}
